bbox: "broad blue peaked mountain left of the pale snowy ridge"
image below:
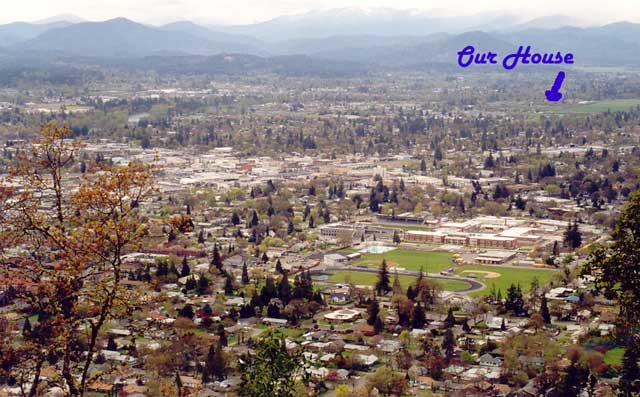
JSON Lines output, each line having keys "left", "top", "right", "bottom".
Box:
{"left": 12, "top": 18, "right": 268, "bottom": 58}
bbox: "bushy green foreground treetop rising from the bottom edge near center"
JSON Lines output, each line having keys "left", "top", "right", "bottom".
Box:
{"left": 239, "top": 331, "right": 308, "bottom": 397}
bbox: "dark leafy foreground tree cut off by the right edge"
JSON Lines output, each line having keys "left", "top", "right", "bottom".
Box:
{"left": 582, "top": 191, "right": 640, "bottom": 334}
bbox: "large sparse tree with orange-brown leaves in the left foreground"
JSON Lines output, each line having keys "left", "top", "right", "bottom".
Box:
{"left": 0, "top": 123, "right": 154, "bottom": 397}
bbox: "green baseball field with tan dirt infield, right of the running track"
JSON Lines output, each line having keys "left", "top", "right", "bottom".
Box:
{"left": 457, "top": 265, "right": 556, "bottom": 296}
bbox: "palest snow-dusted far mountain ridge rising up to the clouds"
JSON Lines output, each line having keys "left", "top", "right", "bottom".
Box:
{"left": 216, "top": 8, "right": 519, "bottom": 41}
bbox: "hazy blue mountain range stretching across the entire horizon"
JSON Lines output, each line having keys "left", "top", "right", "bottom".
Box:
{"left": 0, "top": 8, "right": 640, "bottom": 72}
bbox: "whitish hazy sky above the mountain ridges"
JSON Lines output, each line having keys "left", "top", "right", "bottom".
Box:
{"left": 0, "top": 0, "right": 640, "bottom": 24}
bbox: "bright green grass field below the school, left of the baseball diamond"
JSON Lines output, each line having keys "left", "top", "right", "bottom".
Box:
{"left": 351, "top": 249, "right": 453, "bottom": 273}
